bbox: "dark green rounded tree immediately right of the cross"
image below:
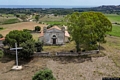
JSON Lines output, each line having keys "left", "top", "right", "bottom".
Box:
{"left": 20, "top": 40, "right": 35, "bottom": 59}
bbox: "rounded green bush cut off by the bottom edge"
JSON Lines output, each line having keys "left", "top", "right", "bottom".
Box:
{"left": 32, "top": 69, "right": 56, "bottom": 80}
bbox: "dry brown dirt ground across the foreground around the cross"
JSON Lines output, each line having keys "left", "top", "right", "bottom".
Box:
{"left": 0, "top": 36, "right": 120, "bottom": 80}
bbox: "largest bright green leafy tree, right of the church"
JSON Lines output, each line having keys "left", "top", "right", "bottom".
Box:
{"left": 65, "top": 12, "right": 112, "bottom": 52}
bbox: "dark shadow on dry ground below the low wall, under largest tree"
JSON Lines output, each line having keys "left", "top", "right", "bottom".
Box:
{"left": 53, "top": 55, "right": 92, "bottom": 64}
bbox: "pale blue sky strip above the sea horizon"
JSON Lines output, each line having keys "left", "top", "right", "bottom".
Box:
{"left": 0, "top": 0, "right": 120, "bottom": 6}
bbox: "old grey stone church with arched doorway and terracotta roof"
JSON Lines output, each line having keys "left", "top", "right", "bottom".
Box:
{"left": 39, "top": 26, "right": 70, "bottom": 45}
